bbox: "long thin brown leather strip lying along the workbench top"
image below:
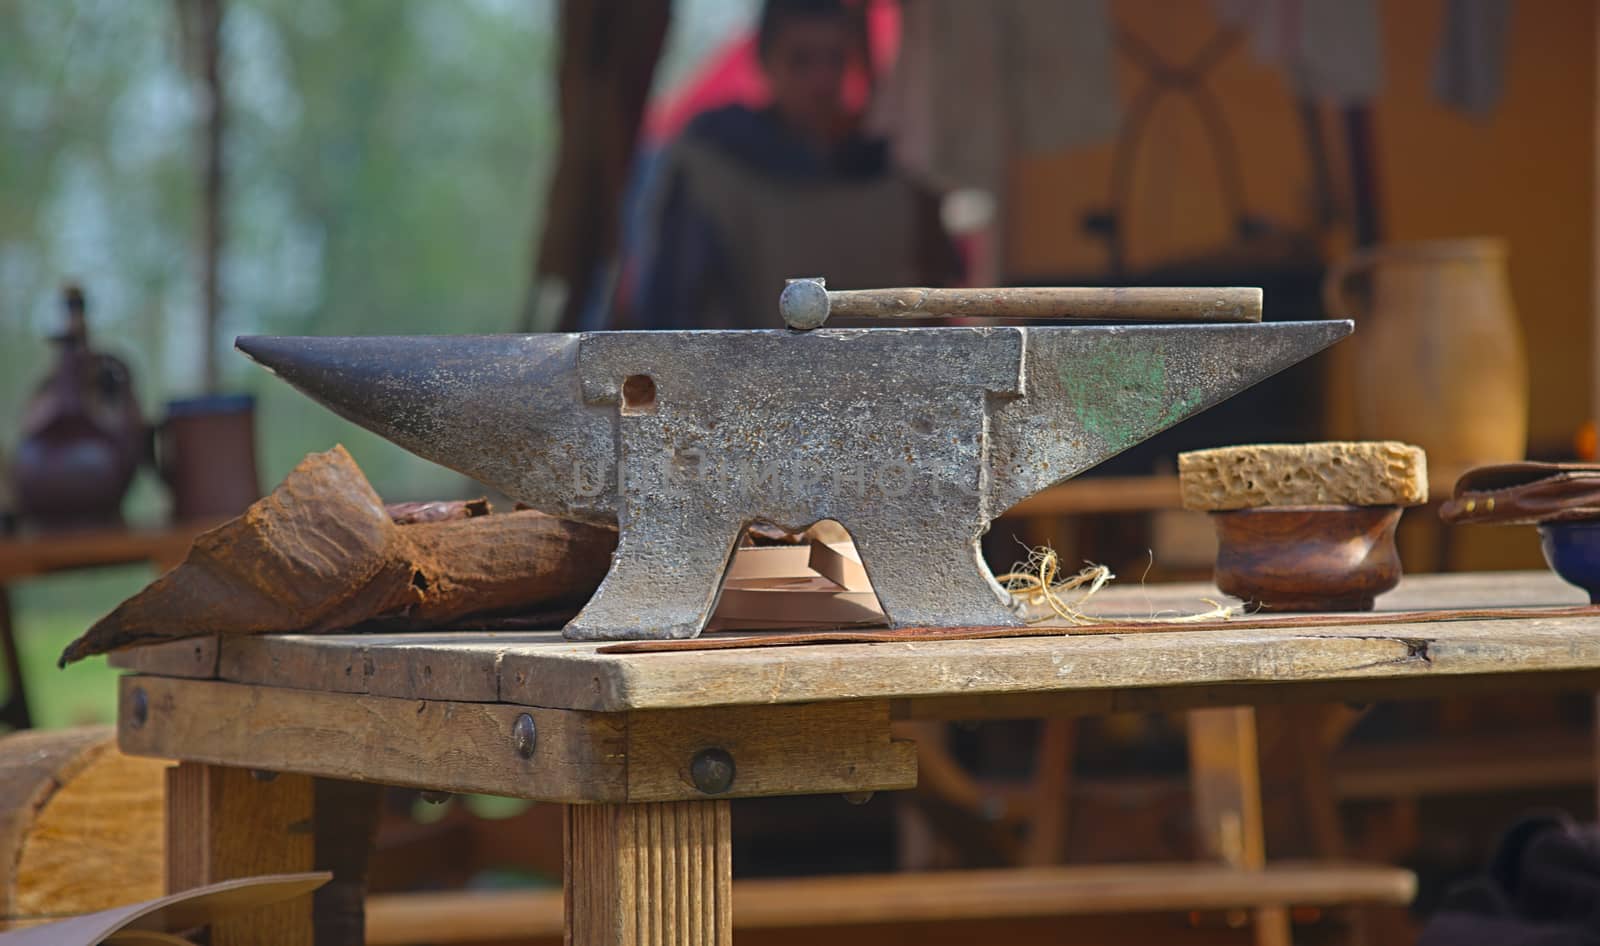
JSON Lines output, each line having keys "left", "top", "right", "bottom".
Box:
{"left": 595, "top": 605, "right": 1600, "bottom": 653}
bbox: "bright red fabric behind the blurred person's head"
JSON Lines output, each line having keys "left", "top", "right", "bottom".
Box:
{"left": 645, "top": 0, "right": 901, "bottom": 147}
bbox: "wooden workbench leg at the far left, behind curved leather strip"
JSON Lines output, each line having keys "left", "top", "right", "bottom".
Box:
{"left": 166, "top": 762, "right": 315, "bottom": 946}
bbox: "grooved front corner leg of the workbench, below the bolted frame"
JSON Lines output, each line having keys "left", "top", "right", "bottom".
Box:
{"left": 563, "top": 800, "right": 733, "bottom": 946}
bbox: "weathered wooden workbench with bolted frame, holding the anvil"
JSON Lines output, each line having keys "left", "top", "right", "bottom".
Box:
{"left": 118, "top": 573, "right": 1600, "bottom": 944}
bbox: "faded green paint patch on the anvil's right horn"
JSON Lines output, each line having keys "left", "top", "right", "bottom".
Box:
{"left": 1056, "top": 336, "right": 1202, "bottom": 450}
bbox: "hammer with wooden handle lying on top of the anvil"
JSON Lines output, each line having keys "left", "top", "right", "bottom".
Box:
{"left": 778, "top": 279, "right": 1261, "bottom": 331}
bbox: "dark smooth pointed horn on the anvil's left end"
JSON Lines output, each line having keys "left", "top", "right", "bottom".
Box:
{"left": 235, "top": 335, "right": 616, "bottom": 523}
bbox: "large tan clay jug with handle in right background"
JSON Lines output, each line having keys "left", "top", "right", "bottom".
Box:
{"left": 1323, "top": 239, "right": 1528, "bottom": 482}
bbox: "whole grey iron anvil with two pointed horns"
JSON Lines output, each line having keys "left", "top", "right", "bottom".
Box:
{"left": 238, "top": 322, "right": 1352, "bottom": 640}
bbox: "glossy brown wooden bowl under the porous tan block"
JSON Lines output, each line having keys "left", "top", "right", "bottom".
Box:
{"left": 1211, "top": 506, "right": 1402, "bottom": 611}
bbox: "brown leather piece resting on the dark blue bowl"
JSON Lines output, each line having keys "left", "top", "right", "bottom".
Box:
{"left": 1438, "top": 463, "right": 1600, "bottom": 525}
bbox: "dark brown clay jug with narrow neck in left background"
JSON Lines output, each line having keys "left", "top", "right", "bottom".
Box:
{"left": 11, "top": 287, "right": 146, "bottom": 528}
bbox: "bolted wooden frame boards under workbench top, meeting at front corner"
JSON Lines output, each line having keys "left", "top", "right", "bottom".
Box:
{"left": 118, "top": 675, "right": 917, "bottom": 802}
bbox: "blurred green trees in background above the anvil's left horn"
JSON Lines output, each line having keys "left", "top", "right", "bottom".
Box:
{"left": 0, "top": 0, "right": 755, "bottom": 519}
